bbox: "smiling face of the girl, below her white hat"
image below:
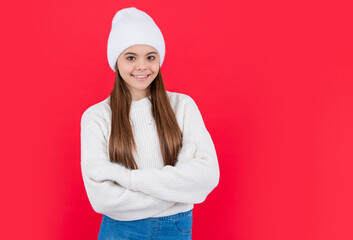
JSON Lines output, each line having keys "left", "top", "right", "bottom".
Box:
{"left": 117, "top": 45, "right": 159, "bottom": 101}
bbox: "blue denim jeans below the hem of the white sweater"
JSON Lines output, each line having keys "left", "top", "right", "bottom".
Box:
{"left": 98, "top": 209, "right": 193, "bottom": 240}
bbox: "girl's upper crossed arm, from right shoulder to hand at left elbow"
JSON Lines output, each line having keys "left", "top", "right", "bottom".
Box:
{"left": 83, "top": 98, "right": 220, "bottom": 206}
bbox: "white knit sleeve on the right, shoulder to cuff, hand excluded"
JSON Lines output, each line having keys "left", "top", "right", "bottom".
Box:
{"left": 127, "top": 97, "right": 220, "bottom": 204}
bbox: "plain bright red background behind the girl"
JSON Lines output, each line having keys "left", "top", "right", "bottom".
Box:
{"left": 0, "top": 0, "right": 353, "bottom": 240}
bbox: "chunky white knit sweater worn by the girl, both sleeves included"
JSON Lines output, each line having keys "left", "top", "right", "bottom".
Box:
{"left": 81, "top": 91, "right": 220, "bottom": 221}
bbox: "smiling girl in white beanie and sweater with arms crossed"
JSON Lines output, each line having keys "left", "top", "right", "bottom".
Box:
{"left": 81, "top": 7, "right": 220, "bottom": 240}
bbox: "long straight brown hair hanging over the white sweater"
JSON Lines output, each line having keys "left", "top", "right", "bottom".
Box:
{"left": 109, "top": 65, "right": 183, "bottom": 169}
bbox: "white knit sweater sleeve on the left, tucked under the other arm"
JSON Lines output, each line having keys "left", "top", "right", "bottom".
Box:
{"left": 81, "top": 111, "right": 175, "bottom": 220}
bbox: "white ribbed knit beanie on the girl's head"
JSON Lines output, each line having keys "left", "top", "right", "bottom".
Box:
{"left": 107, "top": 7, "right": 165, "bottom": 71}
